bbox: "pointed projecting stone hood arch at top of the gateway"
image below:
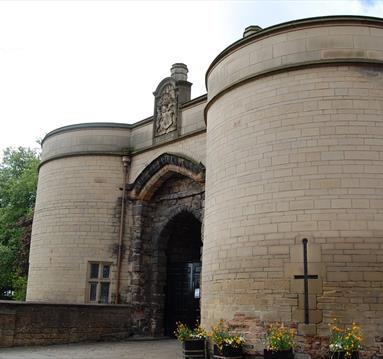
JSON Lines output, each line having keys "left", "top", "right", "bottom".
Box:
{"left": 129, "top": 153, "right": 205, "bottom": 201}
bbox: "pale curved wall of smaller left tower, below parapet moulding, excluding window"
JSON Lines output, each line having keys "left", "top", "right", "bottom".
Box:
{"left": 27, "top": 156, "right": 123, "bottom": 303}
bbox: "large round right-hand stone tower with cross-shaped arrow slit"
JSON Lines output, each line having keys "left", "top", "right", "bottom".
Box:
{"left": 202, "top": 17, "right": 383, "bottom": 358}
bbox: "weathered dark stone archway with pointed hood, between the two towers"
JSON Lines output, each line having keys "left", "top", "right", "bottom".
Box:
{"left": 127, "top": 153, "right": 205, "bottom": 335}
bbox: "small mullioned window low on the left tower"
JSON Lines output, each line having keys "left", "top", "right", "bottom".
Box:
{"left": 87, "top": 262, "right": 110, "bottom": 303}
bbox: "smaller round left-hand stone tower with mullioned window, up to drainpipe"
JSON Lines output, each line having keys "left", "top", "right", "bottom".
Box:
{"left": 27, "top": 123, "right": 130, "bottom": 303}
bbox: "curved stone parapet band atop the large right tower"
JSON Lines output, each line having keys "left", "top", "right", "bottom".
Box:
{"left": 206, "top": 16, "right": 383, "bottom": 105}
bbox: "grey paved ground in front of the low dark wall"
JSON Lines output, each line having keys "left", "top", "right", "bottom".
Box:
{"left": 0, "top": 339, "right": 181, "bottom": 359}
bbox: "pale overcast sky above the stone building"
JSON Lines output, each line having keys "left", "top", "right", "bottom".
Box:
{"left": 0, "top": 0, "right": 383, "bottom": 152}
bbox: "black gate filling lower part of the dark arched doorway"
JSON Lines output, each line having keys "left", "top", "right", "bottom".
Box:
{"left": 165, "top": 262, "right": 202, "bottom": 335}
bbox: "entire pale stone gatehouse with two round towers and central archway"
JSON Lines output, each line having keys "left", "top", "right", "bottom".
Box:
{"left": 23, "top": 16, "right": 383, "bottom": 358}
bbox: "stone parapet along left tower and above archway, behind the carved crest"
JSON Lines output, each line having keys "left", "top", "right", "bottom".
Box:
{"left": 41, "top": 96, "right": 206, "bottom": 164}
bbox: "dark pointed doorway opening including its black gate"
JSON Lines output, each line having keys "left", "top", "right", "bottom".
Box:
{"left": 165, "top": 212, "right": 202, "bottom": 335}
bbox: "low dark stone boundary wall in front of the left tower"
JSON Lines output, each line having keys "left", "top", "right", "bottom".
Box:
{"left": 0, "top": 301, "right": 146, "bottom": 347}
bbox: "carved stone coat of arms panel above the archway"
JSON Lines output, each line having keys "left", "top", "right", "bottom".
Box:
{"left": 155, "top": 84, "right": 177, "bottom": 136}
